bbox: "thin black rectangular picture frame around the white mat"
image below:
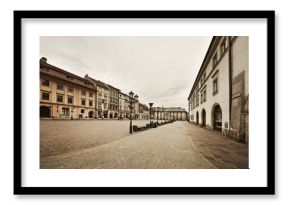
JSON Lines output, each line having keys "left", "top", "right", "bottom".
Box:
{"left": 14, "top": 11, "right": 275, "bottom": 195}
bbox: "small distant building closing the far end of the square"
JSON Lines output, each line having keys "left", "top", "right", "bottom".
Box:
{"left": 152, "top": 107, "right": 187, "bottom": 120}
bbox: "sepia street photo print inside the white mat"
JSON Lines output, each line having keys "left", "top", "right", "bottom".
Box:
{"left": 39, "top": 36, "right": 250, "bottom": 169}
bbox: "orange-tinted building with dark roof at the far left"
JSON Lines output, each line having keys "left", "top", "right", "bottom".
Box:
{"left": 40, "top": 58, "right": 96, "bottom": 119}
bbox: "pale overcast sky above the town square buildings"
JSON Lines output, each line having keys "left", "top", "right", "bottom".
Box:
{"left": 40, "top": 36, "right": 212, "bottom": 110}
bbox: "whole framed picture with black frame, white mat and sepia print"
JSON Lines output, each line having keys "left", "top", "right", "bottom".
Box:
{"left": 14, "top": 11, "right": 275, "bottom": 195}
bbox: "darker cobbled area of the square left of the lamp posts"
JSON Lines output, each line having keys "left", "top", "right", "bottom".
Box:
{"left": 40, "top": 120, "right": 161, "bottom": 157}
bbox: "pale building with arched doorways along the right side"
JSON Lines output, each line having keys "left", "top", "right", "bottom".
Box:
{"left": 187, "top": 36, "right": 249, "bottom": 143}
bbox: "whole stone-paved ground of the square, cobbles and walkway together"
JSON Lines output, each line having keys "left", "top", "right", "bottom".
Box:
{"left": 40, "top": 121, "right": 247, "bottom": 169}
